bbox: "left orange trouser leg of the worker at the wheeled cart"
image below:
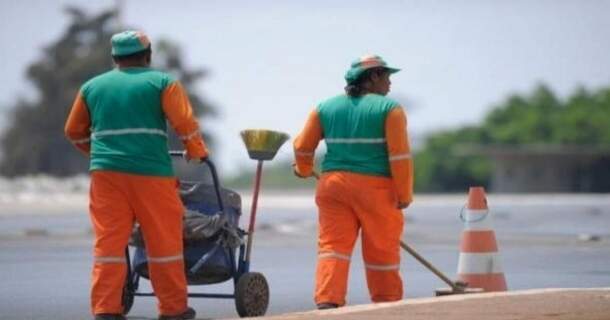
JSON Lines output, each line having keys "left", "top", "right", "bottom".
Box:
{"left": 89, "top": 171, "right": 133, "bottom": 314}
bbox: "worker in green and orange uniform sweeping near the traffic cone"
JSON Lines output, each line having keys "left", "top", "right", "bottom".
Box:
{"left": 294, "top": 55, "right": 413, "bottom": 309}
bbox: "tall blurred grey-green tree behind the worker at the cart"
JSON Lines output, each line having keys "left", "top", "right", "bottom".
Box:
{"left": 0, "top": 7, "right": 214, "bottom": 176}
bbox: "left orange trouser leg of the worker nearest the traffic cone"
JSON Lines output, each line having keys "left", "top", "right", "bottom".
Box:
{"left": 314, "top": 173, "right": 359, "bottom": 306}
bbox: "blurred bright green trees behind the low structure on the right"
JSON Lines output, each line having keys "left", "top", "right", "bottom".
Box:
{"left": 415, "top": 85, "right": 610, "bottom": 192}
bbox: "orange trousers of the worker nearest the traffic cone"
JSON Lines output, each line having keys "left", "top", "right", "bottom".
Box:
{"left": 314, "top": 171, "right": 404, "bottom": 306}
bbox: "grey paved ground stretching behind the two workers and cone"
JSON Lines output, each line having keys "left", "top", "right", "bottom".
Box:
{"left": 0, "top": 197, "right": 610, "bottom": 320}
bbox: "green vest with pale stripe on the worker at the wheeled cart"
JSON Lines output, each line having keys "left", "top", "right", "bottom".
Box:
{"left": 78, "top": 68, "right": 175, "bottom": 177}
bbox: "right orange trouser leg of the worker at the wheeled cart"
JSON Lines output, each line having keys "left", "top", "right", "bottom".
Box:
{"left": 132, "top": 176, "right": 187, "bottom": 315}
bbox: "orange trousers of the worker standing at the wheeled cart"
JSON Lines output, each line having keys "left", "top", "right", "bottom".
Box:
{"left": 89, "top": 171, "right": 187, "bottom": 315}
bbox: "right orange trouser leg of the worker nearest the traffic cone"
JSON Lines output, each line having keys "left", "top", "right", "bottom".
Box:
{"left": 353, "top": 177, "right": 404, "bottom": 302}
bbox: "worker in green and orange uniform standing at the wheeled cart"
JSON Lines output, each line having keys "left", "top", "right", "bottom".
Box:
{"left": 65, "top": 31, "right": 208, "bottom": 320}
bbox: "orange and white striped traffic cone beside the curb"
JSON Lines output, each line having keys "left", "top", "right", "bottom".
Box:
{"left": 458, "top": 187, "right": 507, "bottom": 291}
